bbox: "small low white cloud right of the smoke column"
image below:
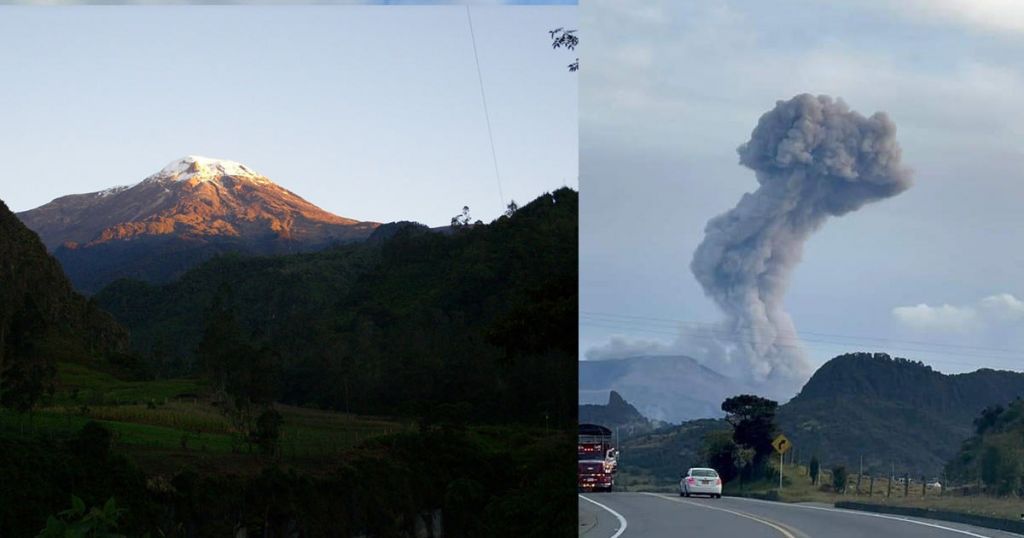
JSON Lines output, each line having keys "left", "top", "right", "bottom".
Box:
{"left": 892, "top": 293, "right": 1024, "bottom": 332}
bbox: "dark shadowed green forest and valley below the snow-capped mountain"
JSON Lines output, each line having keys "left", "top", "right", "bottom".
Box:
{"left": 0, "top": 189, "right": 578, "bottom": 538}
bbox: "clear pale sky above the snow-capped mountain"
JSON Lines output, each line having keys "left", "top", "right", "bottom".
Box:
{"left": 0, "top": 5, "right": 579, "bottom": 225}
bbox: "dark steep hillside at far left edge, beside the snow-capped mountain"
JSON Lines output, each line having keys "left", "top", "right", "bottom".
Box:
{"left": 0, "top": 202, "right": 128, "bottom": 400}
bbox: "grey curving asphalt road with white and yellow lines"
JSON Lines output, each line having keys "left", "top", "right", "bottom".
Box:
{"left": 579, "top": 493, "right": 1021, "bottom": 538}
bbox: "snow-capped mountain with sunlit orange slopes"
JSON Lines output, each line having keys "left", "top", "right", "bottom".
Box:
{"left": 17, "top": 156, "right": 378, "bottom": 292}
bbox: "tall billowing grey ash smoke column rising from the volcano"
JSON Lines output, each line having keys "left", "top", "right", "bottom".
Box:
{"left": 690, "top": 94, "right": 910, "bottom": 381}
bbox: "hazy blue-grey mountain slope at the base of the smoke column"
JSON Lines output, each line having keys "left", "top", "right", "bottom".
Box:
{"left": 580, "top": 356, "right": 750, "bottom": 423}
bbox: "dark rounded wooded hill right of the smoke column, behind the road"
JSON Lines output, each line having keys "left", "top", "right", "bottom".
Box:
{"left": 778, "top": 354, "right": 1024, "bottom": 475}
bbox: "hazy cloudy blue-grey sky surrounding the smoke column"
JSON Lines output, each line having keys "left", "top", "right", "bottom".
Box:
{"left": 580, "top": 0, "right": 1024, "bottom": 383}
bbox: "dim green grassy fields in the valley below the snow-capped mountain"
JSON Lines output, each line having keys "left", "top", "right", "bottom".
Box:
{"left": 0, "top": 363, "right": 412, "bottom": 469}
